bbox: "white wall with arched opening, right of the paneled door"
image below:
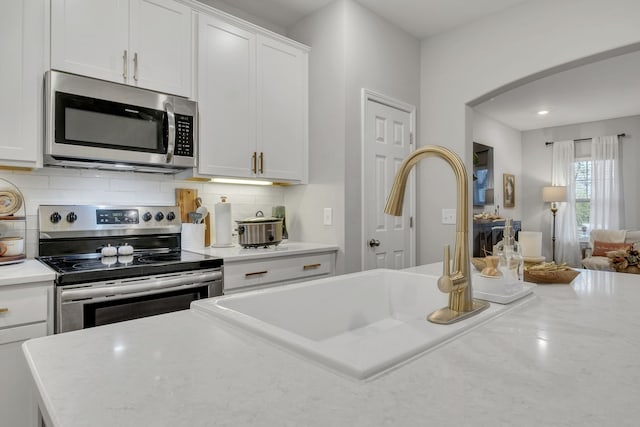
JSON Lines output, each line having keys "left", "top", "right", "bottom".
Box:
{"left": 418, "top": 0, "right": 640, "bottom": 263}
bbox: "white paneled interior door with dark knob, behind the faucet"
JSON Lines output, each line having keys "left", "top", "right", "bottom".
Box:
{"left": 362, "top": 92, "right": 415, "bottom": 270}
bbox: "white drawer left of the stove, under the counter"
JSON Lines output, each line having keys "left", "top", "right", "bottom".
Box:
{"left": 0, "top": 286, "right": 48, "bottom": 329}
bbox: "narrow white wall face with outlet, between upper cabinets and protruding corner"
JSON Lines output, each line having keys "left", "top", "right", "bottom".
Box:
{"left": 286, "top": 1, "right": 346, "bottom": 273}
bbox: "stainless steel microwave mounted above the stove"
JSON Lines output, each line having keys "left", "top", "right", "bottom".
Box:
{"left": 44, "top": 71, "right": 198, "bottom": 173}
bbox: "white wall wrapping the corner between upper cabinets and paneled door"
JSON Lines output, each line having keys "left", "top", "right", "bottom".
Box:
{"left": 287, "top": 0, "right": 420, "bottom": 272}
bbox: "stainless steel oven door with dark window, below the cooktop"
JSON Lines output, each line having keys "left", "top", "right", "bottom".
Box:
{"left": 55, "top": 269, "right": 223, "bottom": 333}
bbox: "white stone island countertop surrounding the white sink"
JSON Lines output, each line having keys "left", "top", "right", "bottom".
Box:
{"left": 23, "top": 268, "right": 640, "bottom": 427}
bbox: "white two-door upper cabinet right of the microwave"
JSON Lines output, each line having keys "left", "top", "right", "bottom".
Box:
{"left": 197, "top": 14, "right": 308, "bottom": 183}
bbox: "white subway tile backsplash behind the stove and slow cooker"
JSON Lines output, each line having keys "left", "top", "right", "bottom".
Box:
{"left": 0, "top": 167, "right": 285, "bottom": 257}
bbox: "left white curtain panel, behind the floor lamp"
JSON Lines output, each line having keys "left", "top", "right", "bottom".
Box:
{"left": 551, "top": 140, "right": 581, "bottom": 266}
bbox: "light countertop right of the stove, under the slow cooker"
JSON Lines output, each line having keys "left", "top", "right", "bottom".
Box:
{"left": 186, "top": 241, "right": 338, "bottom": 264}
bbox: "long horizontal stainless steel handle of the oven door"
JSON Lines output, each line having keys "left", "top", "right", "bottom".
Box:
{"left": 60, "top": 271, "right": 222, "bottom": 302}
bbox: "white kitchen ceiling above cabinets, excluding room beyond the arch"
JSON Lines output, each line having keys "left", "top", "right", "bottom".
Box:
{"left": 208, "top": 0, "right": 526, "bottom": 39}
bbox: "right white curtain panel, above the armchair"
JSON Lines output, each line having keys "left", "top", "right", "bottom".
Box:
{"left": 589, "top": 135, "right": 622, "bottom": 230}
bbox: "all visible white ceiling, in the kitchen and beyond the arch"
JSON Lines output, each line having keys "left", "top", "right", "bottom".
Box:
{"left": 200, "top": 0, "right": 640, "bottom": 130}
